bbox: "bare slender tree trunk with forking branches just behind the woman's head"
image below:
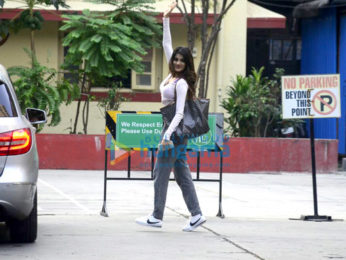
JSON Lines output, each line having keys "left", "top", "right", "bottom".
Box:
{"left": 178, "top": 0, "right": 236, "bottom": 97}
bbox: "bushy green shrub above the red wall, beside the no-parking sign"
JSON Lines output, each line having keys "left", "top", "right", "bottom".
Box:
{"left": 221, "top": 67, "right": 303, "bottom": 137}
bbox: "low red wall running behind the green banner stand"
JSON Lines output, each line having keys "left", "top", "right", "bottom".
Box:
{"left": 37, "top": 134, "right": 338, "bottom": 173}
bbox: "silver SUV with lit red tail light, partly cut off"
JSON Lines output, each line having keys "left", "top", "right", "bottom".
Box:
{"left": 0, "top": 65, "right": 46, "bottom": 242}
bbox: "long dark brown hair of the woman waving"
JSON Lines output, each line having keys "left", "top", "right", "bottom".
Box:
{"left": 169, "top": 47, "right": 197, "bottom": 99}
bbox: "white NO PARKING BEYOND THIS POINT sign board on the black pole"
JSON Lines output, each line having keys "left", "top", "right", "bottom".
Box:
{"left": 281, "top": 74, "right": 341, "bottom": 119}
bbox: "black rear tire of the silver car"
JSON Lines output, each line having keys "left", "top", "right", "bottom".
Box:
{"left": 8, "top": 191, "right": 37, "bottom": 243}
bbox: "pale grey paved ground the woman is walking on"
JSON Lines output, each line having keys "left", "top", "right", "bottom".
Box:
{"left": 0, "top": 170, "right": 346, "bottom": 260}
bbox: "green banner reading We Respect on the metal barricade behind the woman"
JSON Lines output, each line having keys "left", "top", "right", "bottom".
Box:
{"left": 116, "top": 113, "right": 216, "bottom": 150}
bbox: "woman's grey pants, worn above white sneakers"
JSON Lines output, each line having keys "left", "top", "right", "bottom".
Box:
{"left": 153, "top": 135, "right": 201, "bottom": 220}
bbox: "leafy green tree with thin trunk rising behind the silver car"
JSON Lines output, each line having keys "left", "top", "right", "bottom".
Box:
{"left": 0, "top": 0, "right": 79, "bottom": 130}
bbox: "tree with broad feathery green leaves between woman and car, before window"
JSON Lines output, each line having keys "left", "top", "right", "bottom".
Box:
{"left": 60, "top": 0, "right": 161, "bottom": 134}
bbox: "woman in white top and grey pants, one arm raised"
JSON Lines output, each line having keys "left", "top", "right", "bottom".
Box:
{"left": 136, "top": 2, "right": 206, "bottom": 231}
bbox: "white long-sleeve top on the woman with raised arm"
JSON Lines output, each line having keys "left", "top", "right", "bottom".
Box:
{"left": 160, "top": 17, "right": 189, "bottom": 140}
